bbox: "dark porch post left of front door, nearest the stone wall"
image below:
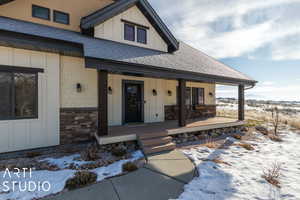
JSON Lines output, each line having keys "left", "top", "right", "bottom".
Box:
{"left": 97, "top": 70, "right": 108, "bottom": 136}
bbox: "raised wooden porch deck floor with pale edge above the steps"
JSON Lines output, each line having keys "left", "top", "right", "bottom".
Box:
{"left": 97, "top": 117, "right": 245, "bottom": 145}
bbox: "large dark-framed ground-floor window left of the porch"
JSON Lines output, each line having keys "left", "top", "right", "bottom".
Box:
{"left": 0, "top": 71, "right": 38, "bottom": 120}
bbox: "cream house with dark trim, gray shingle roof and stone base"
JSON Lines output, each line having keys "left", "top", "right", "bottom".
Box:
{"left": 0, "top": 0, "right": 256, "bottom": 153}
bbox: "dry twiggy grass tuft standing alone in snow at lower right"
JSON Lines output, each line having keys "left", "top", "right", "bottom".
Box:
{"left": 262, "top": 162, "right": 281, "bottom": 188}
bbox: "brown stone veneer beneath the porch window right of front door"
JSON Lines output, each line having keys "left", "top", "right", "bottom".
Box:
{"left": 165, "top": 105, "right": 217, "bottom": 120}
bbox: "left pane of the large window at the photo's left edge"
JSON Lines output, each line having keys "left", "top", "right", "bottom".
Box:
{"left": 0, "top": 72, "right": 12, "bottom": 119}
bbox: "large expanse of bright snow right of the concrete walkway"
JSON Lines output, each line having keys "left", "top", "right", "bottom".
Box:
{"left": 179, "top": 131, "right": 300, "bottom": 200}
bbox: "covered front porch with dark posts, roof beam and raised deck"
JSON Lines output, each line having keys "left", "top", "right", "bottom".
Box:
{"left": 86, "top": 59, "right": 253, "bottom": 145}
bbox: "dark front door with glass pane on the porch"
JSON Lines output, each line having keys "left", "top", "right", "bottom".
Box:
{"left": 124, "top": 83, "right": 143, "bottom": 123}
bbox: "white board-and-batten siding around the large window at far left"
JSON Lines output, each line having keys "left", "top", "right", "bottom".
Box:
{"left": 0, "top": 47, "right": 60, "bottom": 153}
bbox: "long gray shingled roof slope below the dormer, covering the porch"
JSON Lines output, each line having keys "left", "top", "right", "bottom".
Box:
{"left": 0, "top": 17, "right": 256, "bottom": 85}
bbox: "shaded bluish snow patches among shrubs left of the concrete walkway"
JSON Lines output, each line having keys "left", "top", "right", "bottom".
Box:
{"left": 0, "top": 151, "right": 143, "bottom": 200}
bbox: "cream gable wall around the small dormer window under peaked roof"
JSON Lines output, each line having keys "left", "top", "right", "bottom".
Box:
{"left": 95, "top": 6, "right": 168, "bottom": 52}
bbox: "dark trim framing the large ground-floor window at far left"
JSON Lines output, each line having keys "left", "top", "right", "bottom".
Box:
{"left": 0, "top": 65, "right": 44, "bottom": 121}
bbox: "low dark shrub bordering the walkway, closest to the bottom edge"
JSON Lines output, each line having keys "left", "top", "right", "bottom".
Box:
{"left": 65, "top": 171, "right": 97, "bottom": 190}
